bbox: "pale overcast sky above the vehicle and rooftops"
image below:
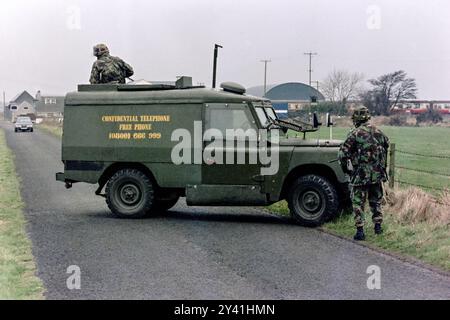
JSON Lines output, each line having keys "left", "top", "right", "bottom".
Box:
{"left": 0, "top": 0, "right": 450, "bottom": 100}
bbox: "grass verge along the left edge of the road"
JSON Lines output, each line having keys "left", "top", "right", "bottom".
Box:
{"left": 0, "top": 131, "right": 43, "bottom": 300}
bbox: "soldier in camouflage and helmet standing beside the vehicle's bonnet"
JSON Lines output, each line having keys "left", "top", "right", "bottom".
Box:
{"left": 339, "top": 107, "right": 389, "bottom": 240}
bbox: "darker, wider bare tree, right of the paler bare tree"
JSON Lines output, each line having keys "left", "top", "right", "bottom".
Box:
{"left": 361, "top": 70, "right": 417, "bottom": 115}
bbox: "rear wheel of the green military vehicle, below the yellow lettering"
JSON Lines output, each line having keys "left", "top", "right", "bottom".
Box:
{"left": 106, "top": 169, "right": 155, "bottom": 219}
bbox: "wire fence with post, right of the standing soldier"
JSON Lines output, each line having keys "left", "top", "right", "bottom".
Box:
{"left": 389, "top": 144, "right": 450, "bottom": 192}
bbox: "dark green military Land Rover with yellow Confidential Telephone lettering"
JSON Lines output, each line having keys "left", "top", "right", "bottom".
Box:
{"left": 56, "top": 77, "right": 348, "bottom": 226}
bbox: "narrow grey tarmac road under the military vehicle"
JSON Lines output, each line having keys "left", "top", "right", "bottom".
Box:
{"left": 0, "top": 122, "right": 450, "bottom": 299}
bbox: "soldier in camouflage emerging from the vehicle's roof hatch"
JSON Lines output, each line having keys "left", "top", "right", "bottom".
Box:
{"left": 89, "top": 44, "right": 134, "bottom": 84}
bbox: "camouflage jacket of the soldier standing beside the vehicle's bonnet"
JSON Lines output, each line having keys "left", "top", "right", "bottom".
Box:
{"left": 339, "top": 123, "right": 389, "bottom": 186}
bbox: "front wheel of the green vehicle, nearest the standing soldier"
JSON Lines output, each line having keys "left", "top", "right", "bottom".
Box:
{"left": 288, "top": 174, "right": 339, "bottom": 227}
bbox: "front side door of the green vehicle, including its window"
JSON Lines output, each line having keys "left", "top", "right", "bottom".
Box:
{"left": 202, "top": 103, "right": 264, "bottom": 185}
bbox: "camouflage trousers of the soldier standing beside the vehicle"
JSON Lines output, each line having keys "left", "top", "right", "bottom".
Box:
{"left": 352, "top": 182, "right": 383, "bottom": 227}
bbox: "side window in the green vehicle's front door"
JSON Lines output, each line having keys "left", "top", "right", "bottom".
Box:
{"left": 205, "top": 107, "right": 256, "bottom": 139}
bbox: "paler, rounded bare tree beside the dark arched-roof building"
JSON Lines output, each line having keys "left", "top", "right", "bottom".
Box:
{"left": 322, "top": 70, "right": 364, "bottom": 103}
